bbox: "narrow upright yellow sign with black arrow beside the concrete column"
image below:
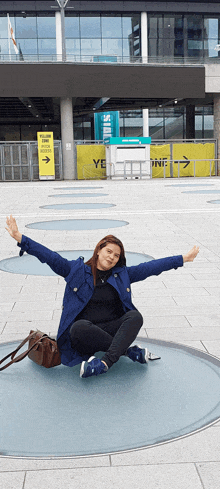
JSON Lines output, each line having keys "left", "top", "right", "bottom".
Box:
{"left": 37, "top": 132, "right": 55, "bottom": 180}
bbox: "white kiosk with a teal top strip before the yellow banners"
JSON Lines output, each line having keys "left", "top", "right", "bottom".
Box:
{"left": 104, "top": 137, "right": 151, "bottom": 179}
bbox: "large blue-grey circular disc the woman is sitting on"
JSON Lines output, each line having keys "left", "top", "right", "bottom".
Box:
{"left": 0, "top": 340, "right": 220, "bottom": 457}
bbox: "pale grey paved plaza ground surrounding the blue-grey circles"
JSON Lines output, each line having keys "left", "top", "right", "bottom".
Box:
{"left": 0, "top": 177, "right": 220, "bottom": 489}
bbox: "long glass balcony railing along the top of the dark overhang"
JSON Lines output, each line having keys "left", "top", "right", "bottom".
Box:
{"left": 0, "top": 53, "right": 220, "bottom": 66}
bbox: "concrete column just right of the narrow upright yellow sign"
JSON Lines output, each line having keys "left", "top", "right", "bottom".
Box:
{"left": 60, "top": 97, "right": 77, "bottom": 180}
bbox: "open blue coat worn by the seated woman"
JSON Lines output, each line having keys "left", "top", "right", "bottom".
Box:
{"left": 18, "top": 235, "right": 183, "bottom": 367}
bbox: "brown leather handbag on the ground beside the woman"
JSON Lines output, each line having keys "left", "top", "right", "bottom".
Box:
{"left": 0, "top": 330, "right": 61, "bottom": 371}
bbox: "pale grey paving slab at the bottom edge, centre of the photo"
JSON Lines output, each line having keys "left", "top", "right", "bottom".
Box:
{"left": 24, "top": 464, "right": 202, "bottom": 489}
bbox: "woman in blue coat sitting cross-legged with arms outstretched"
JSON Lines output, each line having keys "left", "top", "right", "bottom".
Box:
{"left": 6, "top": 216, "right": 199, "bottom": 378}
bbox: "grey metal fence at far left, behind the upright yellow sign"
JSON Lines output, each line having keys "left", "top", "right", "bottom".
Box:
{"left": 0, "top": 141, "right": 63, "bottom": 182}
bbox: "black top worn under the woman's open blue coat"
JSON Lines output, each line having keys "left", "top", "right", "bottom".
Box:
{"left": 75, "top": 270, "right": 125, "bottom": 324}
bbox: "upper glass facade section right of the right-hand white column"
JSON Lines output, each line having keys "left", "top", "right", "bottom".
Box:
{"left": 148, "top": 14, "right": 220, "bottom": 59}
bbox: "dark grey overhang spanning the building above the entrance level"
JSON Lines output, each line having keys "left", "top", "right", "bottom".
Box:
{"left": 0, "top": 61, "right": 205, "bottom": 99}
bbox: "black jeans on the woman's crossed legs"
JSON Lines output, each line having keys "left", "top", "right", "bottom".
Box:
{"left": 70, "top": 310, "right": 143, "bottom": 368}
